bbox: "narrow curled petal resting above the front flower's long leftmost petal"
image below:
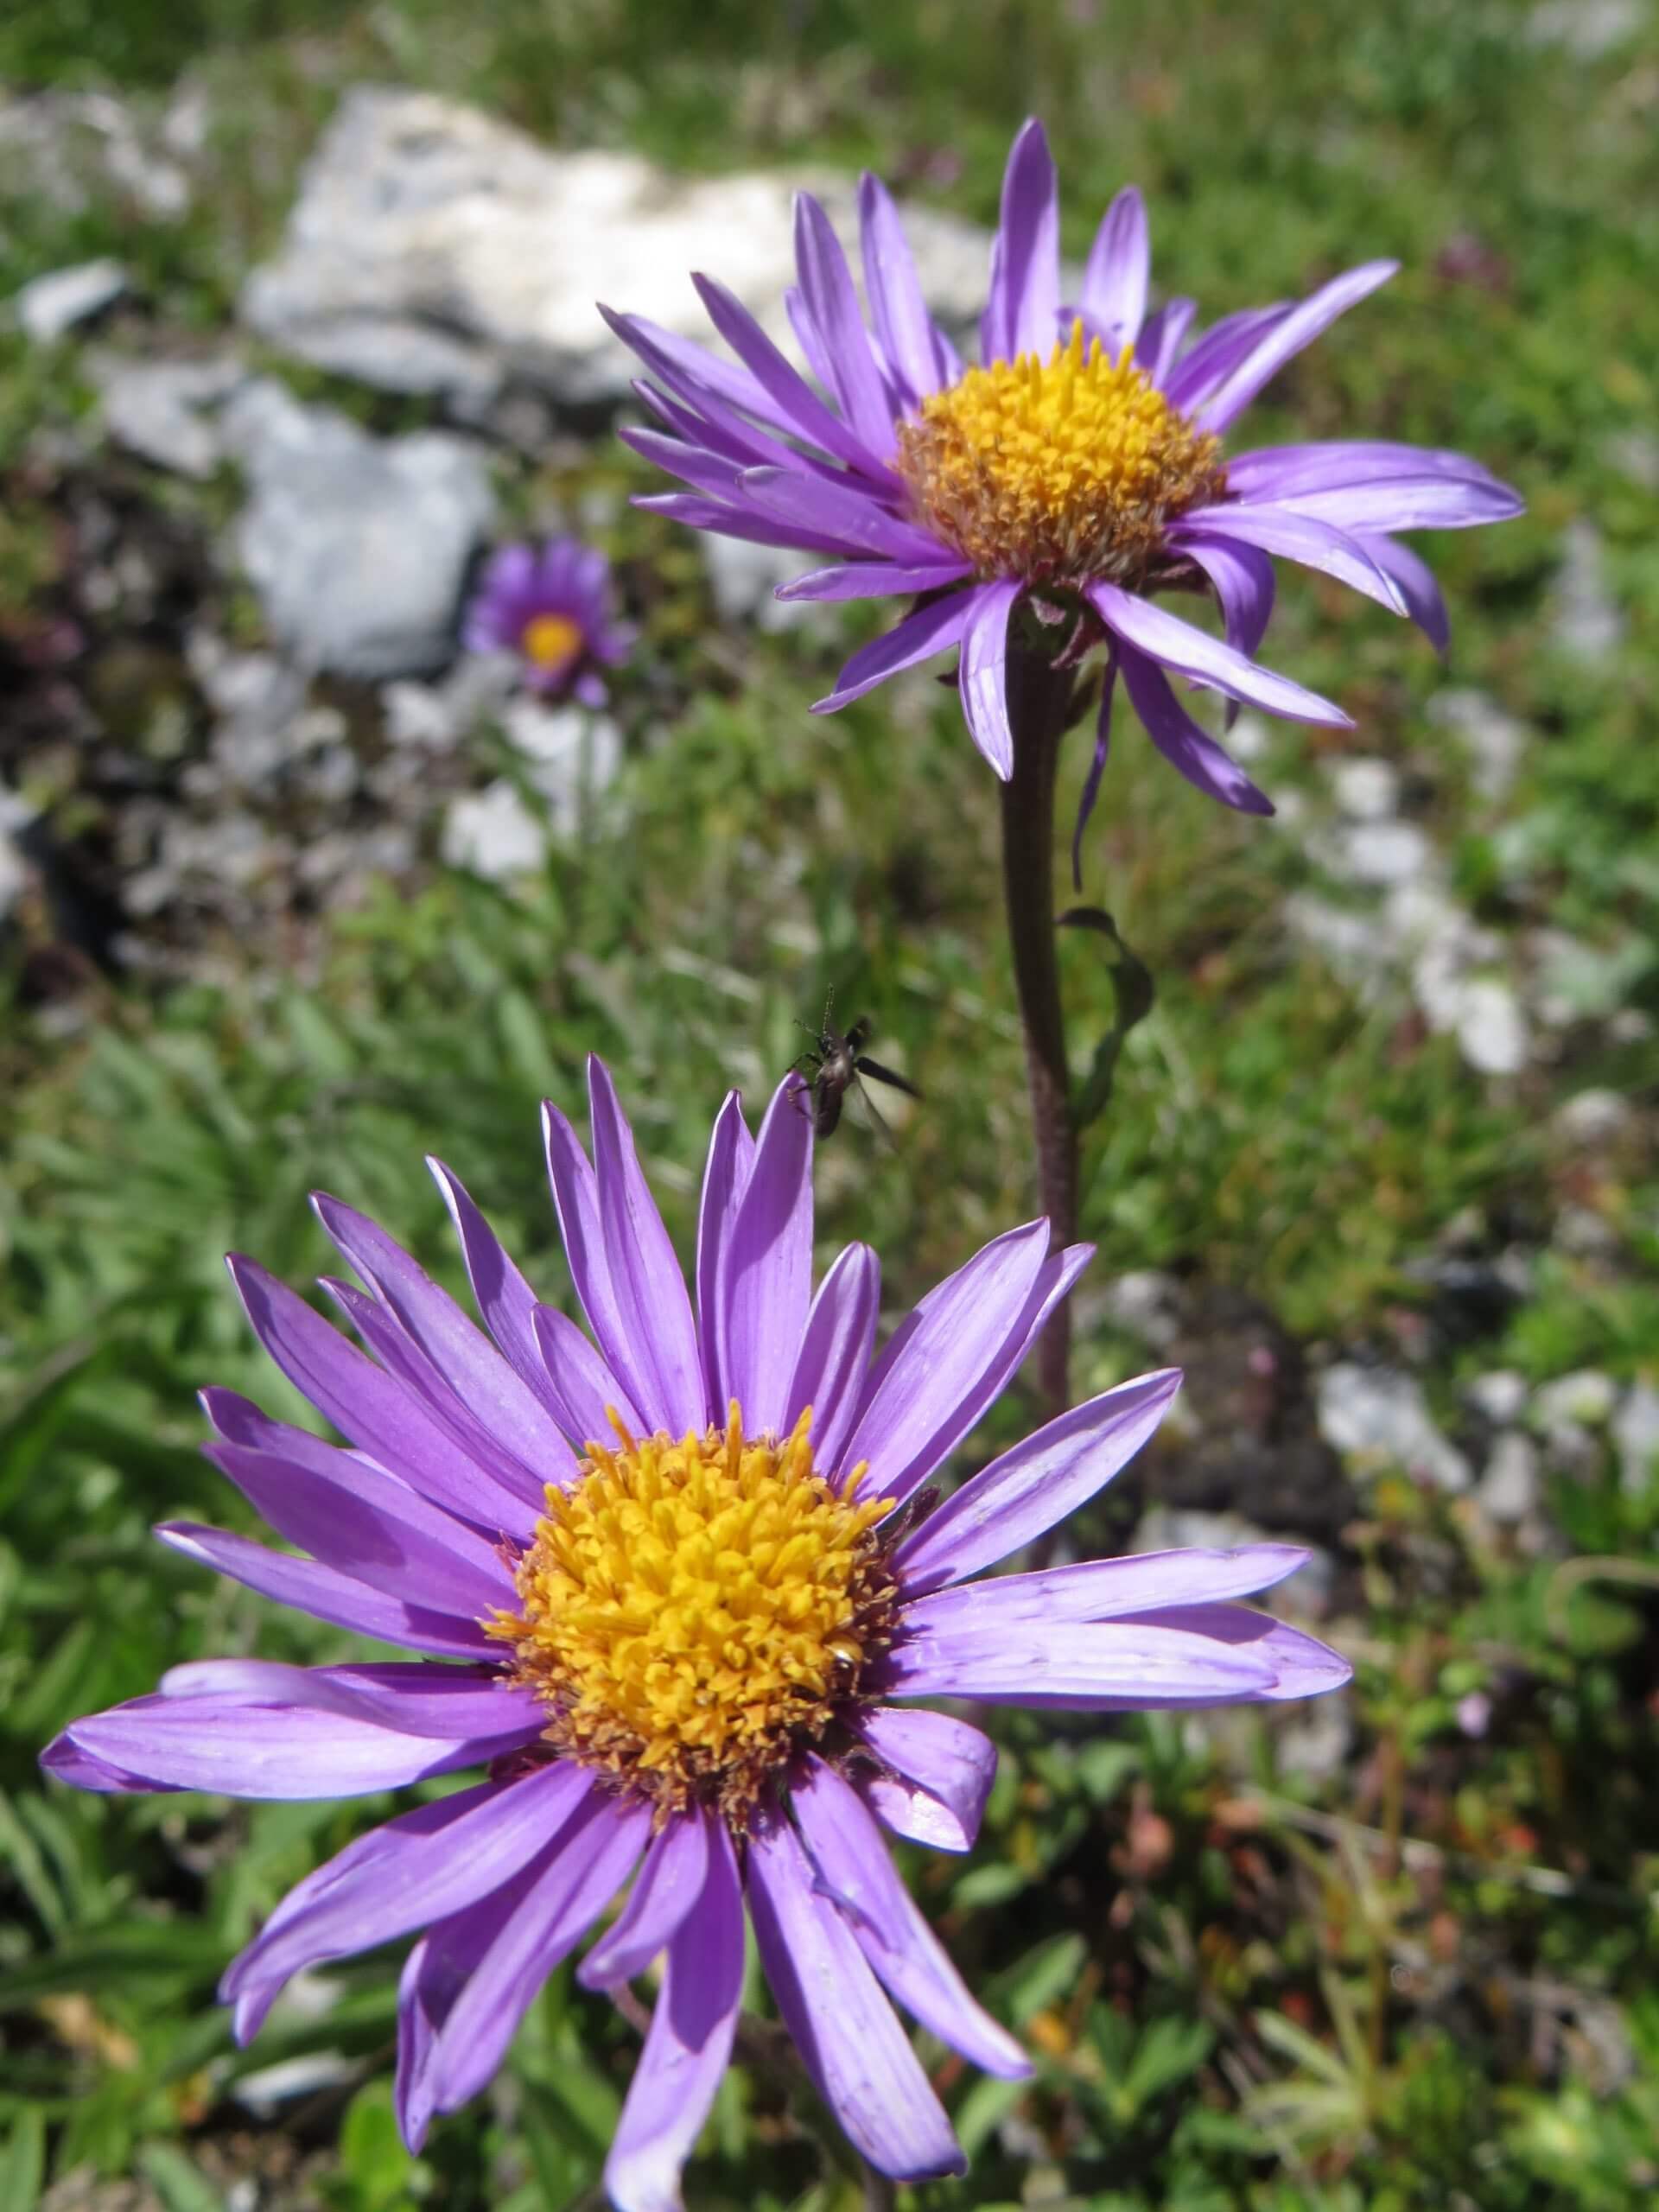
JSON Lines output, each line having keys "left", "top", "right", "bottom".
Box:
{"left": 157, "top": 1659, "right": 535, "bottom": 1743}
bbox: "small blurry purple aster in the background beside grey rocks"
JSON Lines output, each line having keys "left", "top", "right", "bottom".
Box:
{"left": 462, "top": 537, "right": 632, "bottom": 706}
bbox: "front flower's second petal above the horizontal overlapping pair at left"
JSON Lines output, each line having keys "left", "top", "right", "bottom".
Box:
{"left": 206, "top": 1431, "right": 513, "bottom": 1619}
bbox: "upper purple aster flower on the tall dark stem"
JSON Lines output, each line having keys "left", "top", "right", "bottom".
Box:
{"left": 606, "top": 122, "right": 1522, "bottom": 827}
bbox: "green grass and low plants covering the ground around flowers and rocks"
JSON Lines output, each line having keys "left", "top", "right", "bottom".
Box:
{"left": 0, "top": 0, "right": 1659, "bottom": 2212}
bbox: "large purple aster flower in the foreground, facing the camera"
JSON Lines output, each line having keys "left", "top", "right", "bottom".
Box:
{"left": 44, "top": 1062, "right": 1350, "bottom": 2212}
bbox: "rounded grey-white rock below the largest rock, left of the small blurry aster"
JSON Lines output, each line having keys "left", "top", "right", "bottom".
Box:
{"left": 224, "top": 378, "right": 495, "bottom": 679}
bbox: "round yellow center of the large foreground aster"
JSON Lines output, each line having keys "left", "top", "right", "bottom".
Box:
{"left": 486, "top": 1402, "right": 893, "bottom": 1829}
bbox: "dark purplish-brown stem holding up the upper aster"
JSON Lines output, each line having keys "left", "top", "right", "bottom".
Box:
{"left": 1002, "top": 637, "right": 1077, "bottom": 1411}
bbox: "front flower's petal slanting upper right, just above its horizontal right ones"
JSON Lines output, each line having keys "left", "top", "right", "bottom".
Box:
{"left": 893, "top": 1367, "right": 1181, "bottom": 1592}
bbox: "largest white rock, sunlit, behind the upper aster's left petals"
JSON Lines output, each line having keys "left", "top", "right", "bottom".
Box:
{"left": 241, "top": 86, "right": 988, "bottom": 404}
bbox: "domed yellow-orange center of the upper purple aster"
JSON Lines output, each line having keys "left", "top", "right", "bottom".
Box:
{"left": 898, "top": 323, "right": 1225, "bottom": 584}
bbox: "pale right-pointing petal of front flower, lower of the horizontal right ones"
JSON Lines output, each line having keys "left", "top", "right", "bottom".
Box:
{"left": 885, "top": 1621, "right": 1276, "bottom": 1712}
